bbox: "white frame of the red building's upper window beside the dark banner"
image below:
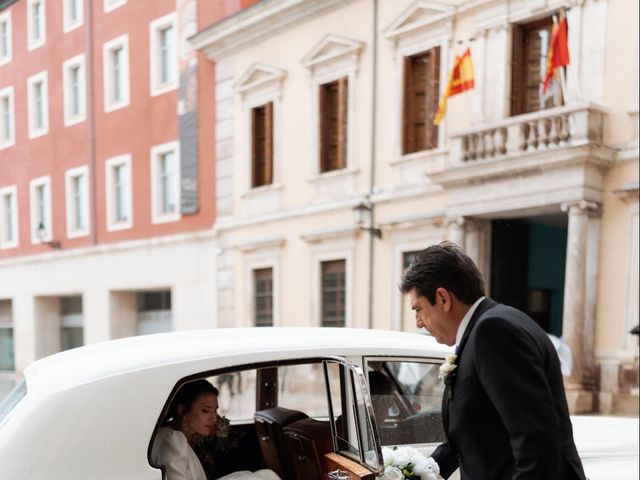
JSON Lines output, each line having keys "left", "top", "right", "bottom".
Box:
{"left": 149, "top": 12, "right": 179, "bottom": 97}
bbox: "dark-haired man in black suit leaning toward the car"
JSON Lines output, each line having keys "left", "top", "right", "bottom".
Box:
{"left": 400, "top": 242, "right": 585, "bottom": 480}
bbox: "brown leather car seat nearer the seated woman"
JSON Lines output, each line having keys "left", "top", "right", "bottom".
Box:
{"left": 253, "top": 407, "right": 307, "bottom": 480}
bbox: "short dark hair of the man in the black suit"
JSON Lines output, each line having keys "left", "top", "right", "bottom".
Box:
{"left": 400, "top": 242, "right": 485, "bottom": 305}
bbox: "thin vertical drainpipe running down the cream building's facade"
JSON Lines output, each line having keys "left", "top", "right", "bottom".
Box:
{"left": 367, "top": 0, "right": 378, "bottom": 329}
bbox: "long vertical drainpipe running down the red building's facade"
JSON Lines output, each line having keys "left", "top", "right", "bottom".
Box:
{"left": 84, "top": 0, "right": 98, "bottom": 245}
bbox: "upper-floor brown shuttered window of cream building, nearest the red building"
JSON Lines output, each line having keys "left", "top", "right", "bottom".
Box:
{"left": 251, "top": 102, "right": 273, "bottom": 188}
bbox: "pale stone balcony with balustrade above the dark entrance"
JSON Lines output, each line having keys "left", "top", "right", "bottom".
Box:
{"left": 429, "top": 104, "right": 615, "bottom": 217}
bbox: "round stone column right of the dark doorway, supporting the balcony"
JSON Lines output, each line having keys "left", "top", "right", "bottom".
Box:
{"left": 562, "top": 201, "right": 597, "bottom": 413}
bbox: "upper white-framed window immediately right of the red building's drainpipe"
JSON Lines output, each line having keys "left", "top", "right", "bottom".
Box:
{"left": 103, "top": 35, "right": 129, "bottom": 112}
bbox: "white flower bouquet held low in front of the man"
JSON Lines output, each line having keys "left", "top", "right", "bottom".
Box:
{"left": 382, "top": 447, "right": 442, "bottom": 480}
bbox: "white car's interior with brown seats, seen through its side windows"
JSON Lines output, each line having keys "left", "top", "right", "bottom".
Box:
{"left": 150, "top": 358, "right": 442, "bottom": 480}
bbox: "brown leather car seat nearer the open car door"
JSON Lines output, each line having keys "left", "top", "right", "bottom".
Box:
{"left": 283, "top": 418, "right": 333, "bottom": 480}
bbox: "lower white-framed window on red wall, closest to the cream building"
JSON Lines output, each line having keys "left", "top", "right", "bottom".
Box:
{"left": 151, "top": 142, "right": 180, "bottom": 223}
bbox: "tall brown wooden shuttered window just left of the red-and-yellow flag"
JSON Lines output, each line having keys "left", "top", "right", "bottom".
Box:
{"left": 402, "top": 47, "right": 440, "bottom": 154}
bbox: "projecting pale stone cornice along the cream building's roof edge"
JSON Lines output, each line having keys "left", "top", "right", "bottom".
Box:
{"left": 189, "top": 0, "right": 354, "bottom": 61}
